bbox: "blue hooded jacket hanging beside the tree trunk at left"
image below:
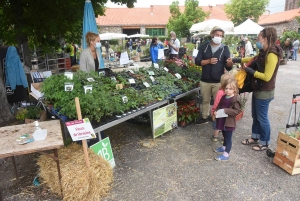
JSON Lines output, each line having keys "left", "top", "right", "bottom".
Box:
{"left": 5, "top": 46, "right": 28, "bottom": 90}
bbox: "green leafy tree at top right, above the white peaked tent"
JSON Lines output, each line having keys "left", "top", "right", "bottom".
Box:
{"left": 224, "top": 0, "right": 269, "bottom": 26}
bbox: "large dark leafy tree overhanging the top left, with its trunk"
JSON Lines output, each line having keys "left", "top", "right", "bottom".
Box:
{"left": 0, "top": 0, "right": 136, "bottom": 125}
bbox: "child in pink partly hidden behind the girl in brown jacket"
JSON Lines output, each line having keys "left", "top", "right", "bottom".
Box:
{"left": 211, "top": 73, "right": 233, "bottom": 142}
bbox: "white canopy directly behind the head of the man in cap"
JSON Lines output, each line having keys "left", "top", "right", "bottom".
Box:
{"left": 190, "top": 19, "right": 234, "bottom": 34}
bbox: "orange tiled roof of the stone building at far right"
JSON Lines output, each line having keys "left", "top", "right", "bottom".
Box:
{"left": 258, "top": 8, "right": 300, "bottom": 25}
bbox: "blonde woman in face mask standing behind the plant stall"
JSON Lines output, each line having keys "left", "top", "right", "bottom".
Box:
{"left": 79, "top": 32, "right": 104, "bottom": 72}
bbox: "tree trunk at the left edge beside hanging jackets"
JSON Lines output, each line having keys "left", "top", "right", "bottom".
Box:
{"left": 0, "top": 63, "right": 15, "bottom": 127}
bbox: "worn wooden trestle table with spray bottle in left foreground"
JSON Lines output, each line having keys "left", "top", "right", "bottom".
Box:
{"left": 0, "top": 120, "right": 64, "bottom": 197}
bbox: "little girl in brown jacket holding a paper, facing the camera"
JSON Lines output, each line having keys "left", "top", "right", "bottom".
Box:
{"left": 214, "top": 79, "right": 241, "bottom": 161}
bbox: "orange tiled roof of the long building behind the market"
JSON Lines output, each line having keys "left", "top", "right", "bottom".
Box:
{"left": 96, "top": 5, "right": 228, "bottom": 26}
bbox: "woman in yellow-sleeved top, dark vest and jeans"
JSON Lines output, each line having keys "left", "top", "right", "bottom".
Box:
{"left": 241, "top": 27, "right": 283, "bottom": 151}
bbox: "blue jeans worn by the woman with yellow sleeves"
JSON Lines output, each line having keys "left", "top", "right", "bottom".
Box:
{"left": 251, "top": 95, "right": 274, "bottom": 145}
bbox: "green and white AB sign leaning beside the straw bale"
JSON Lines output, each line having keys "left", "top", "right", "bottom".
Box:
{"left": 90, "top": 137, "right": 116, "bottom": 168}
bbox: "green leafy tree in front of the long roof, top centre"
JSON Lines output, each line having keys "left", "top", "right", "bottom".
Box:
{"left": 167, "top": 0, "right": 209, "bottom": 37}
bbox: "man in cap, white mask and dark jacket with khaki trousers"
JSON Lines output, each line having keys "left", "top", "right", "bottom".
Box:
{"left": 195, "top": 27, "right": 233, "bottom": 124}
